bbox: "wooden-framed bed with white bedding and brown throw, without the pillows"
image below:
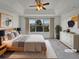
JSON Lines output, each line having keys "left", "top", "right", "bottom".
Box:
{"left": 3, "top": 35, "right": 47, "bottom": 54}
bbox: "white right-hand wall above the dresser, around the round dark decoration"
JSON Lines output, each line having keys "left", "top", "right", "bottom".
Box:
{"left": 61, "top": 9, "right": 79, "bottom": 34}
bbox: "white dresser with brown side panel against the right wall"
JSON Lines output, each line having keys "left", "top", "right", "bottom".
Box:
{"left": 60, "top": 31, "right": 79, "bottom": 50}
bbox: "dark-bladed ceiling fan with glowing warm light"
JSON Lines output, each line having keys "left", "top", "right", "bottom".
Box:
{"left": 30, "top": 0, "right": 49, "bottom": 11}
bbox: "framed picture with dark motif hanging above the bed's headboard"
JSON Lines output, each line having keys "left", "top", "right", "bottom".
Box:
{"left": 1, "top": 13, "right": 12, "bottom": 28}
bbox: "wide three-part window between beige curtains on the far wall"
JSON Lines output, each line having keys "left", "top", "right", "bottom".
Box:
{"left": 29, "top": 19, "right": 49, "bottom": 32}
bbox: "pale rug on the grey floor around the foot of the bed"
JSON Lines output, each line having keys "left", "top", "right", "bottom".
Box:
{"left": 9, "top": 40, "right": 57, "bottom": 59}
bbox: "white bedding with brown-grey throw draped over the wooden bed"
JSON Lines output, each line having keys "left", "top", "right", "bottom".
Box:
{"left": 4, "top": 35, "right": 46, "bottom": 51}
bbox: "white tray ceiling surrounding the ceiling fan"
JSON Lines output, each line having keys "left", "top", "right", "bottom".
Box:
{"left": 0, "top": 0, "right": 79, "bottom": 16}
